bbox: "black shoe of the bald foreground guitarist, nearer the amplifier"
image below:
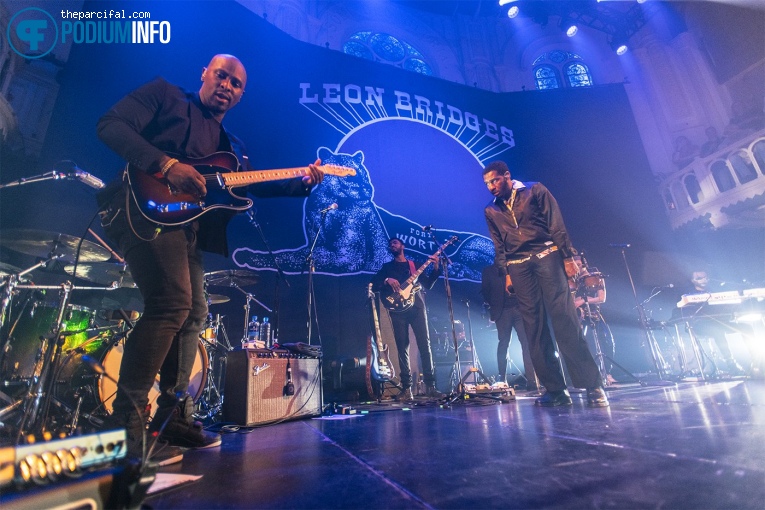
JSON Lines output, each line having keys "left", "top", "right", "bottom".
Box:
{"left": 149, "top": 396, "right": 222, "bottom": 449}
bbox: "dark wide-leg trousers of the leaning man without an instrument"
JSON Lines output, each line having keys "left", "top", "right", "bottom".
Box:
{"left": 507, "top": 252, "right": 603, "bottom": 391}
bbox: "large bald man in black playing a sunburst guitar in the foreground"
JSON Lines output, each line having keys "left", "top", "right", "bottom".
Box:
{"left": 97, "top": 55, "right": 323, "bottom": 465}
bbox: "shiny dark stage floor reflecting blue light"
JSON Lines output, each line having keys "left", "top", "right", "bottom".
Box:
{"left": 145, "top": 380, "right": 765, "bottom": 509}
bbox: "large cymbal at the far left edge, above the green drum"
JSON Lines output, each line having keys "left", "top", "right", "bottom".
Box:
{"left": 0, "top": 228, "right": 111, "bottom": 262}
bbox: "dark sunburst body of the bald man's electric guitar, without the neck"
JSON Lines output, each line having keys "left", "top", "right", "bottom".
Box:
{"left": 126, "top": 152, "right": 252, "bottom": 226}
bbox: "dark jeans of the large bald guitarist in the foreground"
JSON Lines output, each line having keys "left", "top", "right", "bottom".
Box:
{"left": 102, "top": 198, "right": 207, "bottom": 415}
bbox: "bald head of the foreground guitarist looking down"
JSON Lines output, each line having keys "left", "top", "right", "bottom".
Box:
{"left": 199, "top": 54, "right": 247, "bottom": 120}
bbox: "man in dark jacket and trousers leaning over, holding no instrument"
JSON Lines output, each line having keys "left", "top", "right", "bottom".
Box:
{"left": 483, "top": 161, "right": 608, "bottom": 407}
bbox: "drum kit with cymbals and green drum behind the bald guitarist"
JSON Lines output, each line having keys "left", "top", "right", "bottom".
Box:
{"left": 0, "top": 229, "right": 267, "bottom": 443}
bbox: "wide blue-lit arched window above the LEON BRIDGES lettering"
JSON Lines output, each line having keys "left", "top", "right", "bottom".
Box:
{"left": 343, "top": 32, "right": 433, "bottom": 76}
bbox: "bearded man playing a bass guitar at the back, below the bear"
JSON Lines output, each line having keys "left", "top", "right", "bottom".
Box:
{"left": 372, "top": 237, "right": 443, "bottom": 400}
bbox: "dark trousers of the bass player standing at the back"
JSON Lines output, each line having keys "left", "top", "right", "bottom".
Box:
{"left": 390, "top": 297, "right": 436, "bottom": 388}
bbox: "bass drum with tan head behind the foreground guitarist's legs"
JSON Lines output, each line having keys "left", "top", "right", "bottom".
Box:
{"left": 55, "top": 333, "right": 209, "bottom": 416}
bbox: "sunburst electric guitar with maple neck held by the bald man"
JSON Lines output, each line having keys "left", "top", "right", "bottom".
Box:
{"left": 125, "top": 152, "right": 356, "bottom": 226}
